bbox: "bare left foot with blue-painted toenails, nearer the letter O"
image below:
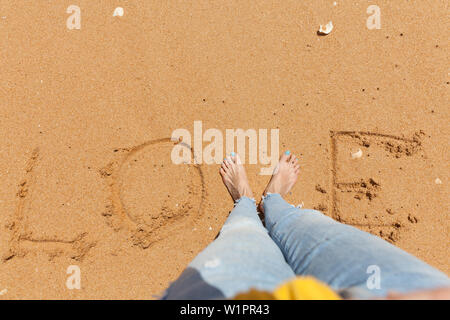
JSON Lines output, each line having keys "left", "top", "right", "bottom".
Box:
{"left": 220, "top": 152, "right": 253, "bottom": 201}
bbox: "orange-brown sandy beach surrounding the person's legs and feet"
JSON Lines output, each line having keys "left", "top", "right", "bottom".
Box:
{"left": 0, "top": 0, "right": 450, "bottom": 299}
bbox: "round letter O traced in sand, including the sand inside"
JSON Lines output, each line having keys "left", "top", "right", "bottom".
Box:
{"left": 100, "top": 138, "right": 206, "bottom": 249}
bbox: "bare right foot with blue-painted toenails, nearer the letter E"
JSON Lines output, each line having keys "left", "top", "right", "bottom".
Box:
{"left": 259, "top": 151, "right": 300, "bottom": 212}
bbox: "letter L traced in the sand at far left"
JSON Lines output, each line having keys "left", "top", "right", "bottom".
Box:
{"left": 2, "top": 148, "right": 95, "bottom": 262}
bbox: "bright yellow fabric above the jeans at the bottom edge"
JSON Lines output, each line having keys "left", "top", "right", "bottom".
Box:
{"left": 234, "top": 277, "right": 340, "bottom": 300}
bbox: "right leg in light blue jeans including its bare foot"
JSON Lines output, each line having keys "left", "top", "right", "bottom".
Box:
{"left": 263, "top": 155, "right": 450, "bottom": 298}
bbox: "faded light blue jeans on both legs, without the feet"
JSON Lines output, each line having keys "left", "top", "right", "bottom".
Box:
{"left": 163, "top": 194, "right": 450, "bottom": 299}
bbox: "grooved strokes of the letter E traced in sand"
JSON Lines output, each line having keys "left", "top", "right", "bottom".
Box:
{"left": 321, "top": 131, "right": 424, "bottom": 242}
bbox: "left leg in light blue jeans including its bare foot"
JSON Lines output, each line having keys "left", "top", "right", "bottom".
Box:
{"left": 165, "top": 156, "right": 295, "bottom": 299}
